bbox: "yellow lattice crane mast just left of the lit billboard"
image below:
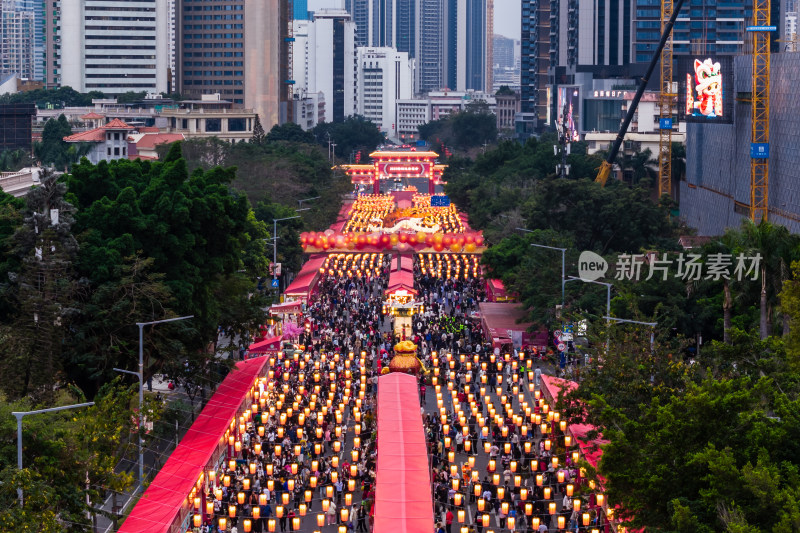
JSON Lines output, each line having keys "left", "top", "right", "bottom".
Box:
{"left": 658, "top": 0, "right": 677, "bottom": 197}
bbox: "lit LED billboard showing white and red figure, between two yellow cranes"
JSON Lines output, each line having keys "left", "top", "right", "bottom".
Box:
{"left": 675, "top": 56, "right": 733, "bottom": 124}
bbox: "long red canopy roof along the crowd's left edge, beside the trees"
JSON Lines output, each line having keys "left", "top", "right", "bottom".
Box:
{"left": 118, "top": 357, "right": 267, "bottom": 533}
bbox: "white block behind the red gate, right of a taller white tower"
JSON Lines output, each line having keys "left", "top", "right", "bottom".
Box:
{"left": 357, "top": 48, "right": 414, "bottom": 136}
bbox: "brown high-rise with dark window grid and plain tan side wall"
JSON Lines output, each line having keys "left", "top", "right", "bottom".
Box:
{"left": 176, "top": 0, "right": 292, "bottom": 129}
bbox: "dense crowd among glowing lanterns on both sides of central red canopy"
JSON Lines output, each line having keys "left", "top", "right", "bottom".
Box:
{"left": 191, "top": 244, "right": 607, "bottom": 533}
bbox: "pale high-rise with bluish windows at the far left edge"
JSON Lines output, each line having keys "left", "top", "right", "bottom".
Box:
{"left": 0, "top": 0, "right": 35, "bottom": 79}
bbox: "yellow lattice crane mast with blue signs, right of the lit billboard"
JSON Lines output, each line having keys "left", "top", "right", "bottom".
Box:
{"left": 750, "top": 0, "right": 772, "bottom": 224}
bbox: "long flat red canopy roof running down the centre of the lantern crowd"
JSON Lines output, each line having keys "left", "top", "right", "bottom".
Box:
{"left": 373, "top": 374, "right": 434, "bottom": 533}
